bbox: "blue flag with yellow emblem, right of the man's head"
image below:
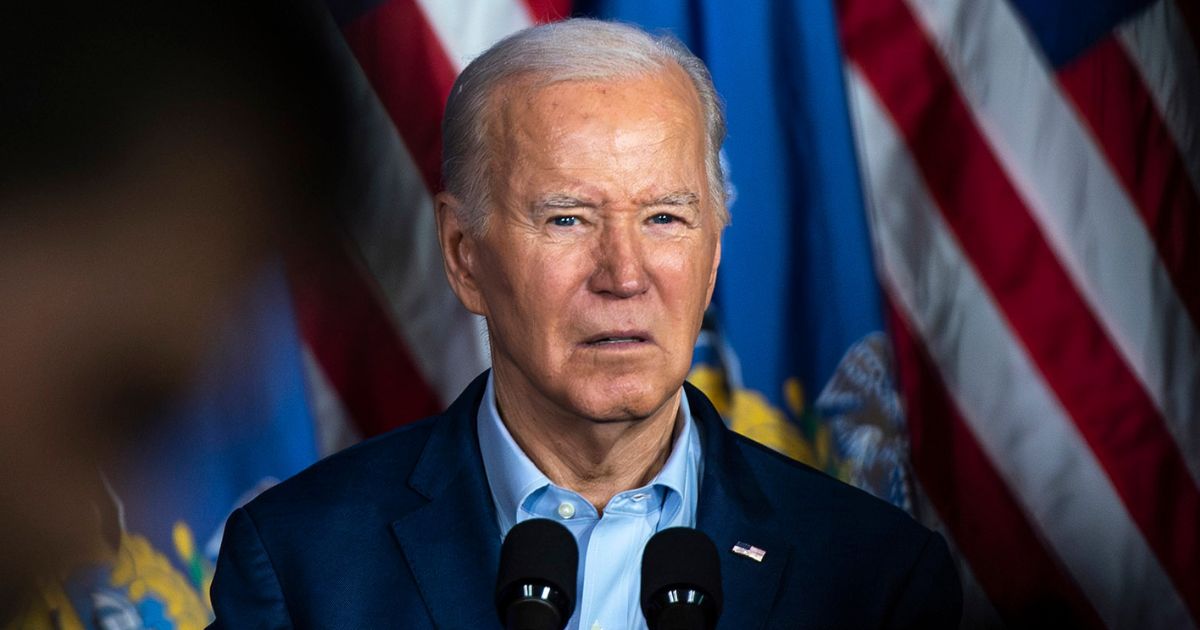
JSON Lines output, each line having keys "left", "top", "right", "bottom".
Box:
{"left": 576, "top": 0, "right": 911, "bottom": 509}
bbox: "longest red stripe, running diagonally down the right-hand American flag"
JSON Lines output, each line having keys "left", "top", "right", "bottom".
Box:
{"left": 839, "top": 0, "right": 1200, "bottom": 619}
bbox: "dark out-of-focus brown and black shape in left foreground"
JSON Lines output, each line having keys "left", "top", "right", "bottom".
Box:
{"left": 0, "top": 1, "right": 342, "bottom": 625}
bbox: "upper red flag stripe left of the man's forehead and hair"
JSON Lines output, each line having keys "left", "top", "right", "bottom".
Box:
{"left": 342, "top": 0, "right": 455, "bottom": 194}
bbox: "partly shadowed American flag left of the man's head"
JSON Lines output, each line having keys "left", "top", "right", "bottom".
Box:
{"left": 290, "top": 0, "right": 569, "bottom": 452}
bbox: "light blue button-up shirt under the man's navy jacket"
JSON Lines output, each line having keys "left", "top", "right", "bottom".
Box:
{"left": 478, "top": 374, "right": 703, "bottom": 630}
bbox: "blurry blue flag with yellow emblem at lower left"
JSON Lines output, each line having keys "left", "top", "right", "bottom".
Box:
{"left": 13, "top": 269, "right": 318, "bottom": 630}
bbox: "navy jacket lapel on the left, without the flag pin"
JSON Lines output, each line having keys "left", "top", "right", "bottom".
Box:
{"left": 391, "top": 377, "right": 500, "bottom": 628}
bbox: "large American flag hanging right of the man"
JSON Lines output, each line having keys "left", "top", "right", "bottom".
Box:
{"left": 839, "top": 0, "right": 1200, "bottom": 628}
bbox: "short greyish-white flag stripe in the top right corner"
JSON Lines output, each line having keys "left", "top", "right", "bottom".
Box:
{"left": 1117, "top": 0, "right": 1200, "bottom": 193}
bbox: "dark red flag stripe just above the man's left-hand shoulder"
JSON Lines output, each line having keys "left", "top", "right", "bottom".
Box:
{"left": 288, "top": 235, "right": 442, "bottom": 437}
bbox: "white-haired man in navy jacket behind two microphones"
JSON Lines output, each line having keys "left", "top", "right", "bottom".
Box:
{"left": 212, "top": 20, "right": 961, "bottom": 630}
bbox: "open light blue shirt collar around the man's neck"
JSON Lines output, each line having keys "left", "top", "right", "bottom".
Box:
{"left": 476, "top": 372, "right": 701, "bottom": 536}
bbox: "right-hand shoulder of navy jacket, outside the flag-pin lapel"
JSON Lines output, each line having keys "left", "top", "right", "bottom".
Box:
{"left": 715, "top": 427, "right": 961, "bottom": 628}
